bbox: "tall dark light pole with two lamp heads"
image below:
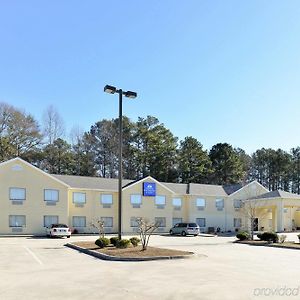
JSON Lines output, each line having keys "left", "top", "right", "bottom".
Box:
{"left": 104, "top": 85, "right": 137, "bottom": 239}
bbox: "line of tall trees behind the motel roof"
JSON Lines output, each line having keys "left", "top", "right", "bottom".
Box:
{"left": 0, "top": 103, "right": 300, "bottom": 193}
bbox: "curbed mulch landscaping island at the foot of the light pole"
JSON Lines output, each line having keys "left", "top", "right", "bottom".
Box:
{"left": 66, "top": 241, "right": 194, "bottom": 261}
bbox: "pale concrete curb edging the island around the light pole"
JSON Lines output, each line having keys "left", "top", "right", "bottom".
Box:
{"left": 65, "top": 243, "right": 195, "bottom": 261}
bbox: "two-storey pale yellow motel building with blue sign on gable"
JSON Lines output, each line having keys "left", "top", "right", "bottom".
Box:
{"left": 0, "top": 158, "right": 300, "bottom": 235}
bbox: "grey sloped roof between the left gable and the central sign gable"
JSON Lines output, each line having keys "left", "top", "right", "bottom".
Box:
{"left": 51, "top": 174, "right": 133, "bottom": 192}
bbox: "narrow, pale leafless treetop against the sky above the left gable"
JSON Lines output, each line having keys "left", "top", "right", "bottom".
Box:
{"left": 43, "top": 105, "right": 65, "bottom": 145}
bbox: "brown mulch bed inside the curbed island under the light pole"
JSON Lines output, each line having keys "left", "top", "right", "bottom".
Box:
{"left": 73, "top": 242, "right": 193, "bottom": 258}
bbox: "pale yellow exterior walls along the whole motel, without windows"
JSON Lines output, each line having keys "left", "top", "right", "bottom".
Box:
{"left": 0, "top": 159, "right": 300, "bottom": 234}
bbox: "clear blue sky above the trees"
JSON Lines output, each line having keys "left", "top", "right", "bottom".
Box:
{"left": 0, "top": 0, "right": 300, "bottom": 153}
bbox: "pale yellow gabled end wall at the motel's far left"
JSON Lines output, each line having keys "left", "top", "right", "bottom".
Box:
{"left": 0, "top": 161, "right": 68, "bottom": 234}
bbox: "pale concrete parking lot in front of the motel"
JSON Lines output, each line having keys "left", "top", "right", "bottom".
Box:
{"left": 0, "top": 234, "right": 300, "bottom": 300}
